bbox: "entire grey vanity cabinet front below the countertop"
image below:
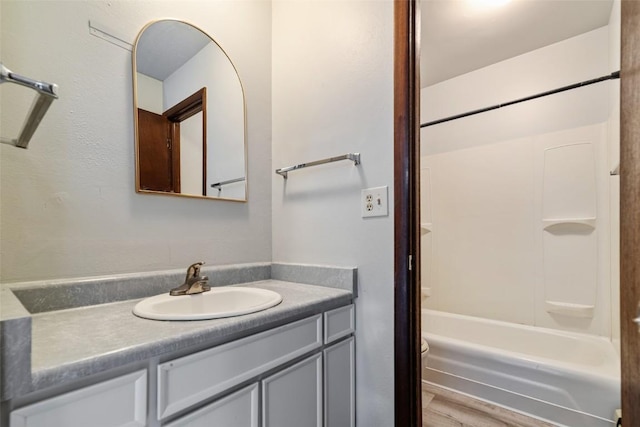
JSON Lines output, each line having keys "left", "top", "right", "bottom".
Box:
{"left": 10, "top": 305, "right": 355, "bottom": 427}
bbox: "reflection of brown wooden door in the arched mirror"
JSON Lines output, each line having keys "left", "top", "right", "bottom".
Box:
{"left": 138, "top": 108, "right": 180, "bottom": 193}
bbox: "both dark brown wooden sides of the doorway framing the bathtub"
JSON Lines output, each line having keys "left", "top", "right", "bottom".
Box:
{"left": 394, "top": 0, "right": 640, "bottom": 427}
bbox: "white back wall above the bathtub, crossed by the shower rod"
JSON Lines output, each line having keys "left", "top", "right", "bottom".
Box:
{"left": 421, "top": 27, "right": 615, "bottom": 336}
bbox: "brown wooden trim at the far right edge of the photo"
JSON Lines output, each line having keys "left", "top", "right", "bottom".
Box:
{"left": 620, "top": 0, "right": 640, "bottom": 426}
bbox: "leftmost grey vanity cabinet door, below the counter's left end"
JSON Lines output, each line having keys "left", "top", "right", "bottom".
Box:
{"left": 10, "top": 371, "right": 147, "bottom": 427}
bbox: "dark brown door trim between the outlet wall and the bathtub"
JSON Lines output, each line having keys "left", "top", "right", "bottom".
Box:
{"left": 394, "top": 0, "right": 422, "bottom": 427}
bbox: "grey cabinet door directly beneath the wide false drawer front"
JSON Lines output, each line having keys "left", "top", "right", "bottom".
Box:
{"left": 166, "top": 383, "right": 259, "bottom": 427}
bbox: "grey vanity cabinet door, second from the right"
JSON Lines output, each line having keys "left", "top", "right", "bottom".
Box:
{"left": 262, "top": 353, "right": 322, "bottom": 427}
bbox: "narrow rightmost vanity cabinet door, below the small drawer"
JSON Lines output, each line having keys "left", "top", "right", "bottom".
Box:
{"left": 324, "top": 337, "right": 356, "bottom": 427}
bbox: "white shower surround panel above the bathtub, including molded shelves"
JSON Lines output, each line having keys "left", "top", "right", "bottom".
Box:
{"left": 422, "top": 123, "right": 610, "bottom": 335}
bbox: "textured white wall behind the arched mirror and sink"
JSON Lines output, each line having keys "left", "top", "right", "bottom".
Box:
{"left": 0, "top": 0, "right": 273, "bottom": 281}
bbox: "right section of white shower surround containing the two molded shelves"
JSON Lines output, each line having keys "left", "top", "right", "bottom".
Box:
{"left": 536, "top": 122, "right": 611, "bottom": 335}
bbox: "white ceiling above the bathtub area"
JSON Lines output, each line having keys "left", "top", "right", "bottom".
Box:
{"left": 420, "top": 0, "right": 613, "bottom": 87}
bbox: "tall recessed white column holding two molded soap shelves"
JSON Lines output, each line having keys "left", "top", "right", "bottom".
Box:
{"left": 540, "top": 142, "right": 604, "bottom": 322}
